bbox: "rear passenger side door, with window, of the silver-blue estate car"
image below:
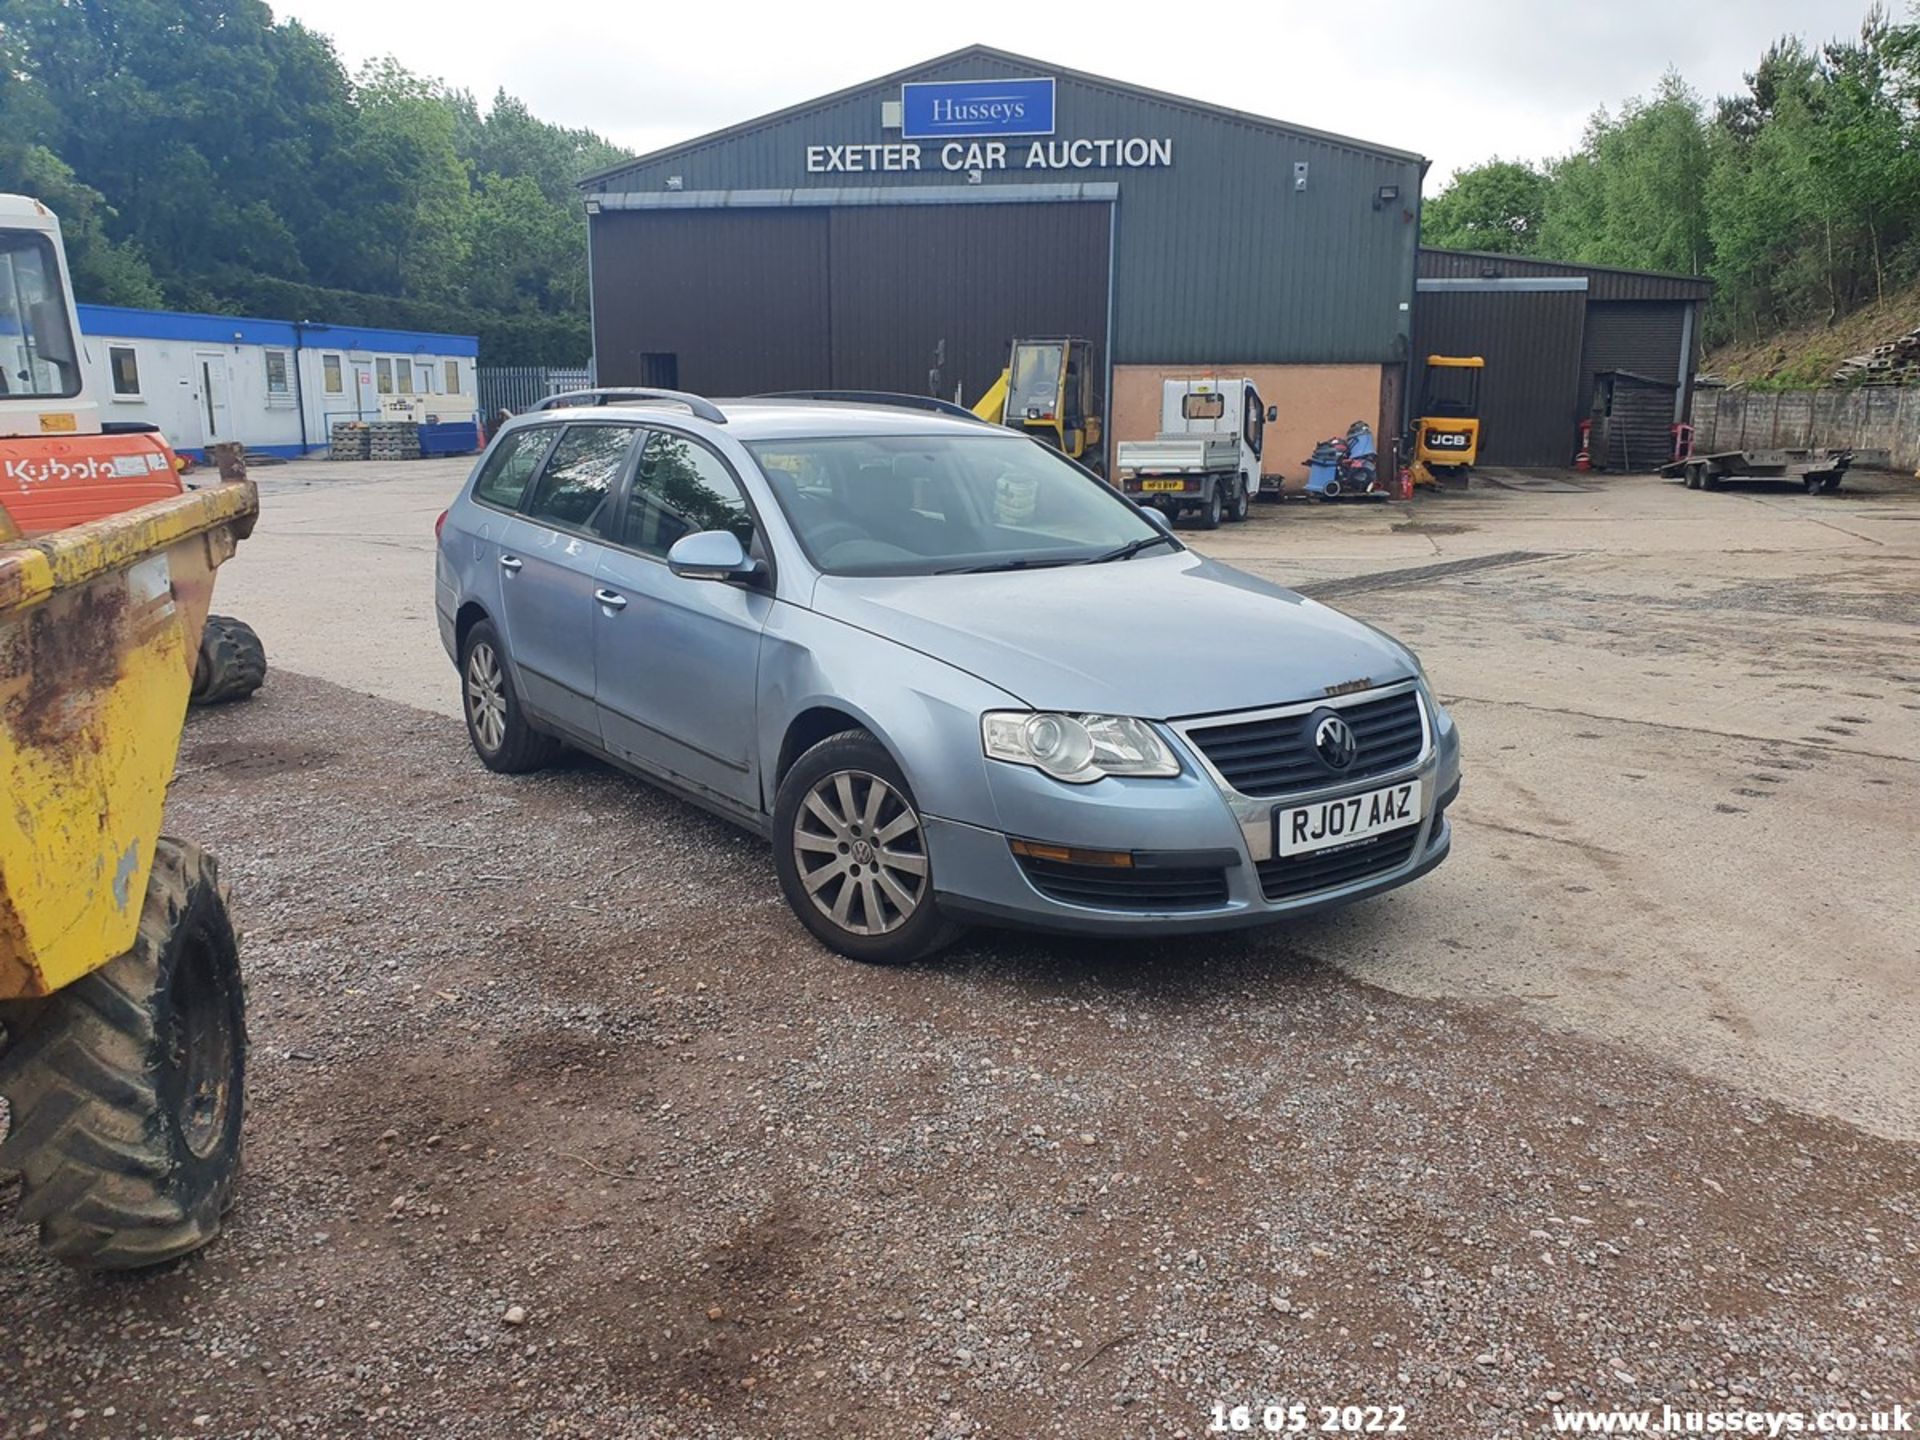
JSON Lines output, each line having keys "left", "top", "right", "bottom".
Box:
{"left": 499, "top": 420, "right": 639, "bottom": 743}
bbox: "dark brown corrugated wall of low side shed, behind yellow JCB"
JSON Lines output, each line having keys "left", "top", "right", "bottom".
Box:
{"left": 1413, "top": 290, "right": 1586, "bottom": 465}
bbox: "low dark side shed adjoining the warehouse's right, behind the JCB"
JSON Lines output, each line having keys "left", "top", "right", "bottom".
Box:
{"left": 1415, "top": 248, "right": 1713, "bottom": 470}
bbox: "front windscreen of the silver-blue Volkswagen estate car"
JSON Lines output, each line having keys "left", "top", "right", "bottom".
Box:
{"left": 747, "top": 432, "right": 1177, "bottom": 576}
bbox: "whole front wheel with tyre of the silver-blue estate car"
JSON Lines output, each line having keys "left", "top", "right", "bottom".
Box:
{"left": 774, "top": 730, "right": 962, "bottom": 966}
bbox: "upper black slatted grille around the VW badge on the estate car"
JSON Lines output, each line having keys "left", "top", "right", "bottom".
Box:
{"left": 1187, "top": 689, "right": 1425, "bottom": 795}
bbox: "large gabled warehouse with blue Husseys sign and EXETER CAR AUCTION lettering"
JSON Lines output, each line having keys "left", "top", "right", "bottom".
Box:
{"left": 582, "top": 46, "right": 1425, "bottom": 478}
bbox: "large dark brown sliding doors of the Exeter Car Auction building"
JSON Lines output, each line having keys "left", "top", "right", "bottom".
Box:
{"left": 593, "top": 202, "right": 1112, "bottom": 401}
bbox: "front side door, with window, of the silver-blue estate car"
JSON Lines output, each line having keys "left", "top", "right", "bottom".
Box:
{"left": 593, "top": 428, "right": 774, "bottom": 810}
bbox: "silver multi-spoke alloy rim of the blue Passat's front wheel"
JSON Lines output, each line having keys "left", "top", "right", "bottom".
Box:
{"left": 793, "top": 770, "right": 927, "bottom": 935}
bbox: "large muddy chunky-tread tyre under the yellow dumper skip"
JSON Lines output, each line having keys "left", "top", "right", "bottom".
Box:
{"left": 0, "top": 837, "right": 246, "bottom": 1269}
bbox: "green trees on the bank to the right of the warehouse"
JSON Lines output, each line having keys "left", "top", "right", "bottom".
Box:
{"left": 1421, "top": 6, "right": 1920, "bottom": 347}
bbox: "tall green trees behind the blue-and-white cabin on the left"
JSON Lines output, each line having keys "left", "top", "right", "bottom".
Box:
{"left": 0, "top": 0, "right": 620, "bottom": 365}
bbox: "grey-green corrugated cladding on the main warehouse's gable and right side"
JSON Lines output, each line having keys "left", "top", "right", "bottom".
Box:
{"left": 588, "top": 54, "right": 1421, "bottom": 366}
